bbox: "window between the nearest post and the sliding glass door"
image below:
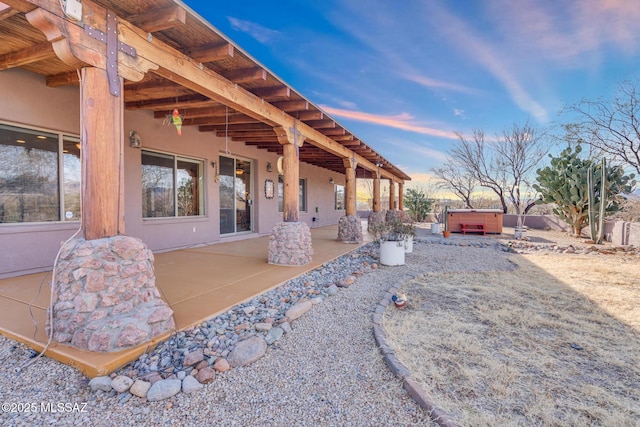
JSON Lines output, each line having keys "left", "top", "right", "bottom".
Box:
{"left": 142, "top": 150, "right": 204, "bottom": 218}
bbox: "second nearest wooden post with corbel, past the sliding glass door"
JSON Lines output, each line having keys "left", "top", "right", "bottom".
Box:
{"left": 273, "top": 126, "right": 304, "bottom": 222}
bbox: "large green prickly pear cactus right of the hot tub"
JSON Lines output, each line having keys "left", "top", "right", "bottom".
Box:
{"left": 533, "top": 145, "right": 635, "bottom": 236}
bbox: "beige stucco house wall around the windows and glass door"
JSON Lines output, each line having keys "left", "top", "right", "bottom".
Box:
{"left": 0, "top": 70, "right": 345, "bottom": 278}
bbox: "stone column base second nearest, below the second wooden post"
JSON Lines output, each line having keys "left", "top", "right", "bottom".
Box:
{"left": 269, "top": 222, "right": 313, "bottom": 266}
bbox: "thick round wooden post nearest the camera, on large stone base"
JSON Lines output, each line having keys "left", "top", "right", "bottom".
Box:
{"left": 80, "top": 68, "right": 124, "bottom": 240}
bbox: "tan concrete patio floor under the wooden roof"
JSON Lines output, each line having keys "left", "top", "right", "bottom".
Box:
{"left": 0, "top": 225, "right": 370, "bottom": 377}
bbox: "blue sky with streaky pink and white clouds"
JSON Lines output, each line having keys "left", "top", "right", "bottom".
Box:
{"left": 185, "top": 0, "right": 640, "bottom": 185}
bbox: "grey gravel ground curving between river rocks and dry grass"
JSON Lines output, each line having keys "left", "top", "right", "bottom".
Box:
{"left": 0, "top": 228, "right": 600, "bottom": 426}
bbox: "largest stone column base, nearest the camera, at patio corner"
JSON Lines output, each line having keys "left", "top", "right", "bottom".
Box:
{"left": 47, "top": 236, "right": 175, "bottom": 353}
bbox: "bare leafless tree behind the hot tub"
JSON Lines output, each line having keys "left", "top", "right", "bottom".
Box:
{"left": 449, "top": 123, "right": 549, "bottom": 214}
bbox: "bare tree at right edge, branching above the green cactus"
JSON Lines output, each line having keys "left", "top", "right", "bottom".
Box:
{"left": 565, "top": 81, "right": 640, "bottom": 174}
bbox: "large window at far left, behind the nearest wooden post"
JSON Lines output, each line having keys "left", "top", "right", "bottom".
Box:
{"left": 0, "top": 124, "right": 80, "bottom": 223}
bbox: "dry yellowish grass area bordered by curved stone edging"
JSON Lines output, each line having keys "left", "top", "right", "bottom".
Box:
{"left": 384, "top": 254, "right": 640, "bottom": 426}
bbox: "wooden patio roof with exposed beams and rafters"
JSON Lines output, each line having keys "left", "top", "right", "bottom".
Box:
{"left": 0, "top": 0, "right": 411, "bottom": 182}
